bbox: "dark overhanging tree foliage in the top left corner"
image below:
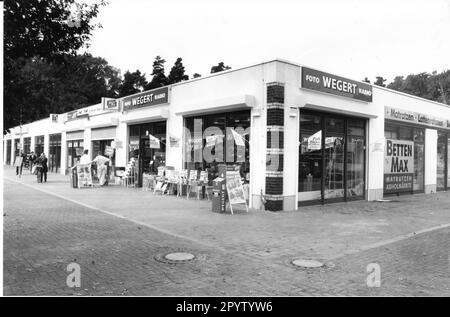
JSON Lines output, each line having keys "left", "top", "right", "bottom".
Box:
{"left": 4, "top": 0, "right": 106, "bottom": 59}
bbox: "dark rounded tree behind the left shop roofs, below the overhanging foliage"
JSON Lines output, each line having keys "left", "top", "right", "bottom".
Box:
{"left": 10, "top": 54, "right": 120, "bottom": 121}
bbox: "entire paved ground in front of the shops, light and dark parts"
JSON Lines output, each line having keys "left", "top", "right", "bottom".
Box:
{"left": 4, "top": 167, "right": 450, "bottom": 296}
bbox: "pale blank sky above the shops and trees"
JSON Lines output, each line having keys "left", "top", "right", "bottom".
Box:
{"left": 83, "top": 0, "right": 450, "bottom": 83}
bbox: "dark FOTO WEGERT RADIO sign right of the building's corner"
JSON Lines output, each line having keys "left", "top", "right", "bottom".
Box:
{"left": 301, "top": 67, "right": 372, "bottom": 102}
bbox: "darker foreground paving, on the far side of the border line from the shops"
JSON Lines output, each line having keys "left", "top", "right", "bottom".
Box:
{"left": 4, "top": 180, "right": 450, "bottom": 296}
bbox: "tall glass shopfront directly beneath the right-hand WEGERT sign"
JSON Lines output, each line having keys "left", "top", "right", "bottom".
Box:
{"left": 298, "top": 111, "right": 366, "bottom": 204}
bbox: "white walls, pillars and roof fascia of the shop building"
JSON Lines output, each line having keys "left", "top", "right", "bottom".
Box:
{"left": 4, "top": 60, "right": 450, "bottom": 210}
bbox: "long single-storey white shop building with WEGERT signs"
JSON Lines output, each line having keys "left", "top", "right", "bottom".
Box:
{"left": 4, "top": 59, "right": 450, "bottom": 211}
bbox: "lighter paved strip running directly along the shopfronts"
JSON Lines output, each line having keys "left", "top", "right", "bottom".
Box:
{"left": 4, "top": 167, "right": 450, "bottom": 263}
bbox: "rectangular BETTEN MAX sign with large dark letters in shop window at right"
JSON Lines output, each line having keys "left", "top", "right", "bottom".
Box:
{"left": 384, "top": 139, "right": 414, "bottom": 193}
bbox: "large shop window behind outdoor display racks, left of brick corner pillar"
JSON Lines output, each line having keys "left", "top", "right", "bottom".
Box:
{"left": 184, "top": 110, "right": 250, "bottom": 183}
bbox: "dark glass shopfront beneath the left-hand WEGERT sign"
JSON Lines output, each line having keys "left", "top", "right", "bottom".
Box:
{"left": 128, "top": 121, "right": 167, "bottom": 186}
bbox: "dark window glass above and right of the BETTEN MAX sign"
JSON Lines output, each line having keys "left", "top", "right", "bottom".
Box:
{"left": 384, "top": 122, "right": 425, "bottom": 194}
